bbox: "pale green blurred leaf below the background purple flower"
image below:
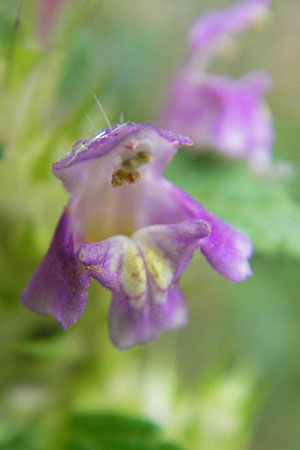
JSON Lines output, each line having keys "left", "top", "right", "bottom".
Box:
{"left": 166, "top": 152, "right": 300, "bottom": 257}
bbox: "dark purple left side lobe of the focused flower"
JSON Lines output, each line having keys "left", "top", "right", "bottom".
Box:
{"left": 20, "top": 210, "right": 89, "bottom": 328}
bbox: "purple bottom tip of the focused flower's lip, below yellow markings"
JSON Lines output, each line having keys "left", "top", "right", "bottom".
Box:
{"left": 109, "top": 285, "right": 188, "bottom": 349}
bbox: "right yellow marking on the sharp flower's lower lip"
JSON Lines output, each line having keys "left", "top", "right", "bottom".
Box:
{"left": 142, "top": 246, "right": 174, "bottom": 289}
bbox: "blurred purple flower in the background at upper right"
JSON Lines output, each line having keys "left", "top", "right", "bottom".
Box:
{"left": 161, "top": 0, "right": 273, "bottom": 171}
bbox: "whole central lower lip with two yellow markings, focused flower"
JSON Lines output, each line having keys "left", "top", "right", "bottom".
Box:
{"left": 78, "top": 219, "right": 211, "bottom": 348}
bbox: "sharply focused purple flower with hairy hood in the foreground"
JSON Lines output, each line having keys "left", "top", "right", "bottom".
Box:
{"left": 21, "top": 123, "right": 252, "bottom": 348}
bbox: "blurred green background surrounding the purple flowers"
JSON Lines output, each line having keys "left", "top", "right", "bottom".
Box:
{"left": 0, "top": 0, "right": 300, "bottom": 450}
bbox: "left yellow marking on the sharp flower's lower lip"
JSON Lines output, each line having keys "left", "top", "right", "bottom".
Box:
{"left": 121, "top": 247, "right": 147, "bottom": 297}
